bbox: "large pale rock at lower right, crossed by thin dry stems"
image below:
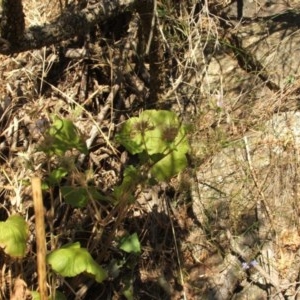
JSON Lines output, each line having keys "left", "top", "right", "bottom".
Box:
{"left": 192, "top": 112, "right": 300, "bottom": 299}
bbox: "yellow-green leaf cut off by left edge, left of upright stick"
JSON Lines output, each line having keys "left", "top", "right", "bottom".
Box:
{"left": 0, "top": 215, "right": 28, "bottom": 257}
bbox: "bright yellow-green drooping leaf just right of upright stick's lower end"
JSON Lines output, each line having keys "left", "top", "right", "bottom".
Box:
{"left": 47, "top": 242, "right": 107, "bottom": 282}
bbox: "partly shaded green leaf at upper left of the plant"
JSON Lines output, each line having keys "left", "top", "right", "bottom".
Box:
{"left": 42, "top": 117, "right": 88, "bottom": 155}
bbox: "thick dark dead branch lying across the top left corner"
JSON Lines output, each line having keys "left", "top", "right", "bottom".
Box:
{"left": 0, "top": 0, "right": 136, "bottom": 55}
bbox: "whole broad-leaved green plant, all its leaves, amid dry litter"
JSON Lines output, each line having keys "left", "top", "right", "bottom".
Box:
{"left": 0, "top": 110, "right": 190, "bottom": 299}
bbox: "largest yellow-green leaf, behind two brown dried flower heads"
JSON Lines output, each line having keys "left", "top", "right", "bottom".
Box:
{"left": 117, "top": 110, "right": 190, "bottom": 181}
